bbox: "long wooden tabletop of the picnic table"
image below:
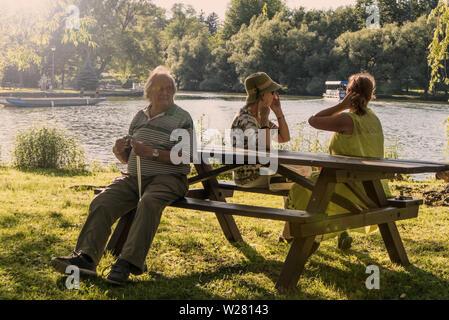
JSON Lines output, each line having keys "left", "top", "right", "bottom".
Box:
{"left": 199, "top": 148, "right": 449, "bottom": 174}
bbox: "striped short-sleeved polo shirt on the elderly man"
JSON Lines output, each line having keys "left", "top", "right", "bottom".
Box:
{"left": 128, "top": 104, "right": 195, "bottom": 176}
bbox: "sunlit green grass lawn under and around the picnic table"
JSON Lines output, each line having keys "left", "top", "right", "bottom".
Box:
{"left": 0, "top": 168, "right": 449, "bottom": 300}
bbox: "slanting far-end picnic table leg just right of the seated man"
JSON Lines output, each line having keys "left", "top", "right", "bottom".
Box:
{"left": 195, "top": 163, "right": 243, "bottom": 242}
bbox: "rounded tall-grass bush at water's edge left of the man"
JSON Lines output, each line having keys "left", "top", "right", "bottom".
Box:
{"left": 12, "top": 127, "right": 86, "bottom": 170}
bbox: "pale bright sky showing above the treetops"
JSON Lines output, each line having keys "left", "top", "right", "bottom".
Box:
{"left": 153, "top": 0, "right": 356, "bottom": 21}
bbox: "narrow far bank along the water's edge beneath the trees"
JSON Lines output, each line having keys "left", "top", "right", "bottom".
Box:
{"left": 0, "top": 88, "right": 448, "bottom": 104}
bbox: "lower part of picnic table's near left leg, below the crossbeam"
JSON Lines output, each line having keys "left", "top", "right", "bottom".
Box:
{"left": 276, "top": 227, "right": 315, "bottom": 292}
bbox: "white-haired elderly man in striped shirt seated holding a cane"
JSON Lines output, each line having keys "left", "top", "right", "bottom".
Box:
{"left": 51, "top": 67, "right": 194, "bottom": 285}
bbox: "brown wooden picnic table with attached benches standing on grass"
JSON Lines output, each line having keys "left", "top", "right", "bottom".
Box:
{"left": 97, "top": 150, "right": 449, "bottom": 290}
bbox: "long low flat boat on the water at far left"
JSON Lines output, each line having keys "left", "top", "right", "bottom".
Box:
{"left": 6, "top": 97, "right": 106, "bottom": 107}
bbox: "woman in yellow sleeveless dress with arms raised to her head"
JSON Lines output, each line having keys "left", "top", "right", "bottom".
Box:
{"left": 281, "top": 74, "right": 391, "bottom": 253}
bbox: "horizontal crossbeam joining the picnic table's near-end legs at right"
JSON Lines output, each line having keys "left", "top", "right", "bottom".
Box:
{"left": 292, "top": 207, "right": 419, "bottom": 237}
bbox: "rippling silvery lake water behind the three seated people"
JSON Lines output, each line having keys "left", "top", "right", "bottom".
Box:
{"left": 0, "top": 93, "right": 449, "bottom": 176}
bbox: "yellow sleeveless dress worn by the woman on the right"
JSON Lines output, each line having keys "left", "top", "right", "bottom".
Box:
{"left": 285, "top": 109, "right": 391, "bottom": 241}
